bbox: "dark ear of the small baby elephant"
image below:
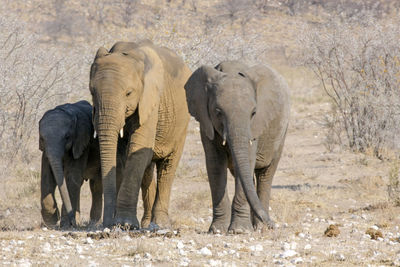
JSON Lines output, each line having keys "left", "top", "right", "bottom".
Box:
{"left": 72, "top": 112, "right": 93, "bottom": 159}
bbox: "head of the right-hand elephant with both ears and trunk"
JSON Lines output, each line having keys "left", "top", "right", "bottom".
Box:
{"left": 185, "top": 62, "right": 278, "bottom": 226}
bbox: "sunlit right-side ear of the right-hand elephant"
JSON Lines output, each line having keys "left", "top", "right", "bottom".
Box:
{"left": 244, "top": 65, "right": 285, "bottom": 138}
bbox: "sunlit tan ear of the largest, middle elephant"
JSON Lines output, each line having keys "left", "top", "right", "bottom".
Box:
{"left": 139, "top": 47, "right": 165, "bottom": 125}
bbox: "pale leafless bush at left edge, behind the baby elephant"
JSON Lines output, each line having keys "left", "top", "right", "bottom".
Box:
{"left": 0, "top": 16, "right": 85, "bottom": 166}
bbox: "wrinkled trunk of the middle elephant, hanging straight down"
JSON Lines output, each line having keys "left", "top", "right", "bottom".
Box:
{"left": 97, "top": 103, "right": 123, "bottom": 227}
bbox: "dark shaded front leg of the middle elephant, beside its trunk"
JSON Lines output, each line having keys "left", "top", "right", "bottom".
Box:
{"left": 115, "top": 148, "right": 153, "bottom": 229}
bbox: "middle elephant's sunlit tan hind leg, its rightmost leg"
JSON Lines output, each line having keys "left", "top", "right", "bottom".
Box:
{"left": 151, "top": 140, "right": 185, "bottom": 228}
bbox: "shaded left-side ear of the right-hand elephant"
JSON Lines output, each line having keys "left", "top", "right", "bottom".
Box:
{"left": 185, "top": 66, "right": 223, "bottom": 140}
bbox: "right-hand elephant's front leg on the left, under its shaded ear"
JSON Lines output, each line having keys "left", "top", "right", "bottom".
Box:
{"left": 201, "top": 133, "right": 231, "bottom": 234}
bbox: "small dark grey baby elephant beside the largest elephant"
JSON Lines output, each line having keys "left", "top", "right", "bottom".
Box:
{"left": 39, "top": 101, "right": 103, "bottom": 227}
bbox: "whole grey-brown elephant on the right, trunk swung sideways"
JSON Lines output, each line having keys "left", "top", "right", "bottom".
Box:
{"left": 185, "top": 61, "right": 290, "bottom": 233}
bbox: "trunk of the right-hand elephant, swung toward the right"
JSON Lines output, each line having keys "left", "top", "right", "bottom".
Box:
{"left": 228, "top": 126, "right": 269, "bottom": 223}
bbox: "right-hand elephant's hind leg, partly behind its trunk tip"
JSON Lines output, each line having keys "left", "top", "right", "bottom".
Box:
{"left": 252, "top": 147, "right": 283, "bottom": 230}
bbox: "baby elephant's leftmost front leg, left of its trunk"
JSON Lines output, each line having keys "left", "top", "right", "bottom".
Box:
{"left": 40, "top": 153, "right": 60, "bottom": 227}
